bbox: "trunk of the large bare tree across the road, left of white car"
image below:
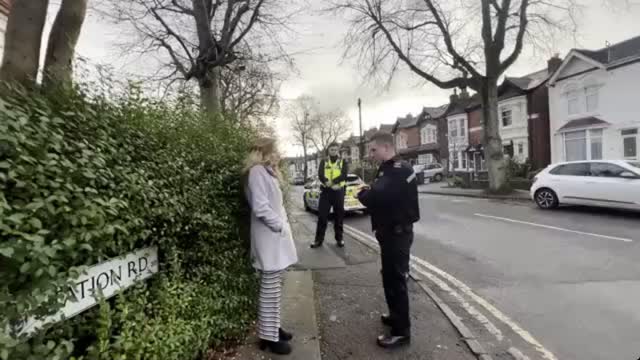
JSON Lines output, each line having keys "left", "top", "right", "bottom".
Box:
{"left": 480, "top": 79, "right": 507, "bottom": 192}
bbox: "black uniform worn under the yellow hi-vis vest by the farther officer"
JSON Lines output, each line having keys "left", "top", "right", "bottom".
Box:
{"left": 311, "top": 157, "right": 349, "bottom": 247}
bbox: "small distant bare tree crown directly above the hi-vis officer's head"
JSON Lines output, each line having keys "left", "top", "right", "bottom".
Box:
{"left": 310, "top": 110, "right": 351, "bottom": 156}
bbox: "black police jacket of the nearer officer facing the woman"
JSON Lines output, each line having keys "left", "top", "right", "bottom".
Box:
{"left": 358, "top": 159, "right": 420, "bottom": 230}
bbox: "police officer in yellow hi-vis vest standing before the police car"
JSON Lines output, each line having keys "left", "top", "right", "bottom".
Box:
{"left": 311, "top": 143, "right": 348, "bottom": 249}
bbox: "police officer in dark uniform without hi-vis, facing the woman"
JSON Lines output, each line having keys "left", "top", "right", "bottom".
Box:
{"left": 358, "top": 133, "right": 420, "bottom": 348}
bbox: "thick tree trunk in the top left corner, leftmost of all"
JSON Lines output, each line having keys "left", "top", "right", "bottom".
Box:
{"left": 0, "top": 0, "right": 49, "bottom": 87}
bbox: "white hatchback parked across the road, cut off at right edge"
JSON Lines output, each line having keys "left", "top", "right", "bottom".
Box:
{"left": 531, "top": 160, "right": 640, "bottom": 210}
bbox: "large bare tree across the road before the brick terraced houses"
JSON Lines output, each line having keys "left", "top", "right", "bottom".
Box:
{"left": 331, "top": 0, "right": 577, "bottom": 191}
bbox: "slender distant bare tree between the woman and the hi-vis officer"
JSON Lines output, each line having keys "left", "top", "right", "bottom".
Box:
{"left": 287, "top": 95, "right": 316, "bottom": 179}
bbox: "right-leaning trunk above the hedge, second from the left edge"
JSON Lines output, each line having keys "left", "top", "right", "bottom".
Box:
{"left": 43, "top": 0, "right": 87, "bottom": 88}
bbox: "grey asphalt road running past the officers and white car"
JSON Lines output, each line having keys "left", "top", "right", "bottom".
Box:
{"left": 296, "top": 189, "right": 640, "bottom": 360}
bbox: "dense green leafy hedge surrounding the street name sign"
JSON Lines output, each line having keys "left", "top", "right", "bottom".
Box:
{"left": 0, "top": 85, "right": 256, "bottom": 360}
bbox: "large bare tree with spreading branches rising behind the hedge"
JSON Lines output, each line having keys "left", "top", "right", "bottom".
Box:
{"left": 107, "top": 0, "right": 296, "bottom": 114}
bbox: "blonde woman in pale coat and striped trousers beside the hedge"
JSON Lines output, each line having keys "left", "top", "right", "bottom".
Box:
{"left": 244, "top": 138, "right": 298, "bottom": 355}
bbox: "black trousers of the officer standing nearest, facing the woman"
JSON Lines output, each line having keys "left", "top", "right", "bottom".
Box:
{"left": 376, "top": 226, "right": 413, "bottom": 336}
